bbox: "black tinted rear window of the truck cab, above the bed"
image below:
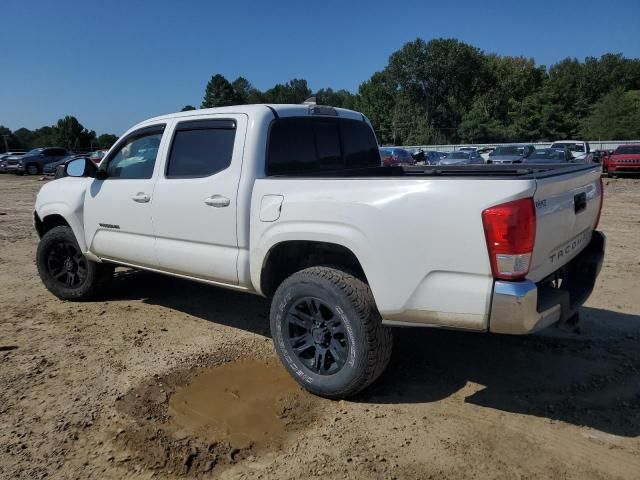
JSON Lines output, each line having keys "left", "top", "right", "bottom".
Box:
{"left": 266, "top": 117, "right": 380, "bottom": 175}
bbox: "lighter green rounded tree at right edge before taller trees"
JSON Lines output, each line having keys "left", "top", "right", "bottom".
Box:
{"left": 581, "top": 87, "right": 640, "bottom": 140}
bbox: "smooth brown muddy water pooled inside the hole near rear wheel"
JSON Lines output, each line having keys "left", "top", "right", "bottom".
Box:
{"left": 167, "top": 359, "right": 317, "bottom": 448}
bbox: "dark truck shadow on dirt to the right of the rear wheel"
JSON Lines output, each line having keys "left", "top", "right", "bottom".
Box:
{"left": 357, "top": 307, "right": 640, "bottom": 437}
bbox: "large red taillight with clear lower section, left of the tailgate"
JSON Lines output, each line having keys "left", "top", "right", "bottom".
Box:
{"left": 482, "top": 198, "right": 536, "bottom": 280}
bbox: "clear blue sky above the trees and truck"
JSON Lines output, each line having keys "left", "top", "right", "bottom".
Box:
{"left": 0, "top": 0, "right": 640, "bottom": 134}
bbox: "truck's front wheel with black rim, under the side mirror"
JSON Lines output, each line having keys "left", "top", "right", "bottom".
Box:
{"left": 36, "top": 226, "right": 114, "bottom": 301}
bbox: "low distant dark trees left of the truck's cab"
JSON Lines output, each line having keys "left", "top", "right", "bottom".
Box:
{"left": 0, "top": 115, "right": 118, "bottom": 152}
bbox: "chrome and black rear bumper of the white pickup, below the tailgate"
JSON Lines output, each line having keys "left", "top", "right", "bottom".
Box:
{"left": 489, "top": 231, "right": 606, "bottom": 335}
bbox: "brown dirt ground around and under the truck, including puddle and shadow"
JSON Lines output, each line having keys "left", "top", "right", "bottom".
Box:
{"left": 0, "top": 175, "right": 640, "bottom": 480}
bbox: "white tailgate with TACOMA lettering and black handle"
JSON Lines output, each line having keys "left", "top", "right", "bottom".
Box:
{"left": 527, "top": 165, "right": 602, "bottom": 282}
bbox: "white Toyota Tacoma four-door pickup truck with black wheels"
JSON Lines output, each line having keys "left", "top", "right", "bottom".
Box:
{"left": 34, "top": 105, "right": 605, "bottom": 398}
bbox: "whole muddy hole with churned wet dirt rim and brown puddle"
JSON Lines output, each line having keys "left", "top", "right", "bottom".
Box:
{"left": 115, "top": 357, "right": 328, "bottom": 476}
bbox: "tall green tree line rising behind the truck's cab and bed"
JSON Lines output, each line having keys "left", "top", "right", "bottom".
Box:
{"left": 195, "top": 39, "right": 640, "bottom": 145}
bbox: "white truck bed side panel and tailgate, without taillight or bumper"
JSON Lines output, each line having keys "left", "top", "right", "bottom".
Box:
{"left": 250, "top": 164, "right": 600, "bottom": 330}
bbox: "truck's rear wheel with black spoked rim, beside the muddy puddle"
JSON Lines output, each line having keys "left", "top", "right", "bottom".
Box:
{"left": 271, "top": 267, "right": 393, "bottom": 399}
